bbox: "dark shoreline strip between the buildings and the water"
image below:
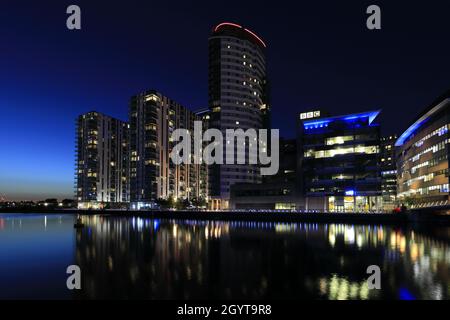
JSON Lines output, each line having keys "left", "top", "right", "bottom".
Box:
{"left": 0, "top": 208, "right": 450, "bottom": 225}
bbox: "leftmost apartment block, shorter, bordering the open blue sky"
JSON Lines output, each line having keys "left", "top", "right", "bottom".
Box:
{"left": 75, "top": 111, "right": 129, "bottom": 209}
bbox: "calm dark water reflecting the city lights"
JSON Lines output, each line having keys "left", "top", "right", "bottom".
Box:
{"left": 0, "top": 214, "right": 450, "bottom": 299}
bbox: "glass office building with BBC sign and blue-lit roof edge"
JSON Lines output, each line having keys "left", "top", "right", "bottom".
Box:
{"left": 298, "top": 111, "right": 382, "bottom": 212}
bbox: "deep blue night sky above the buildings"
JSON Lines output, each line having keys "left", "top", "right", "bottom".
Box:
{"left": 0, "top": 0, "right": 450, "bottom": 200}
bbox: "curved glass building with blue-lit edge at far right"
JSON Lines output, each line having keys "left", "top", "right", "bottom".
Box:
{"left": 396, "top": 91, "right": 450, "bottom": 208}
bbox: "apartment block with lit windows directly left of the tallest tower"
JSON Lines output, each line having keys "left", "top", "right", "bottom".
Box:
{"left": 129, "top": 90, "right": 208, "bottom": 209}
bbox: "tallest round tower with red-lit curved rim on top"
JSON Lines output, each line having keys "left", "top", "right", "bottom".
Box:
{"left": 208, "top": 22, "right": 270, "bottom": 208}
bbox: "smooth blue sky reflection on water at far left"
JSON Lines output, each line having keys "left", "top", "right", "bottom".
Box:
{"left": 0, "top": 214, "right": 76, "bottom": 299}
